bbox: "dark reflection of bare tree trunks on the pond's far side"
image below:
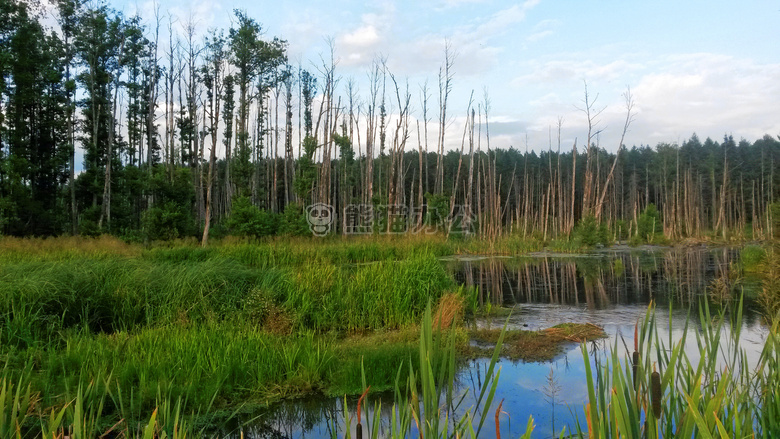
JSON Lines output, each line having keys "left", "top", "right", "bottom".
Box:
{"left": 453, "top": 248, "right": 738, "bottom": 309}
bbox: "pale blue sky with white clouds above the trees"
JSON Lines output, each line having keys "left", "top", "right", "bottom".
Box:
{"left": 105, "top": 0, "right": 780, "bottom": 151}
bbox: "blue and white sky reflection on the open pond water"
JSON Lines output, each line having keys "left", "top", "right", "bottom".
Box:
{"left": 463, "top": 312, "right": 769, "bottom": 438}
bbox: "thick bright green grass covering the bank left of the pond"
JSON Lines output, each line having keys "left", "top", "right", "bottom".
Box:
{"left": 0, "top": 241, "right": 455, "bottom": 428}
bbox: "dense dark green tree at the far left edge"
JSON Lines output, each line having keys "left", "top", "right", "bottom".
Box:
{"left": 0, "top": 2, "right": 67, "bottom": 235}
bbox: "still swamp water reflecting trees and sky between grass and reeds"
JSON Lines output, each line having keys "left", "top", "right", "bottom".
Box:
{"left": 238, "top": 247, "right": 768, "bottom": 438}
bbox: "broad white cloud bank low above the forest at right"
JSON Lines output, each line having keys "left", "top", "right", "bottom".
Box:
{"left": 500, "top": 53, "right": 780, "bottom": 151}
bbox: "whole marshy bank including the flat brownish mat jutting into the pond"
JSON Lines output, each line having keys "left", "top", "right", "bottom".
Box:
{"left": 0, "top": 236, "right": 776, "bottom": 437}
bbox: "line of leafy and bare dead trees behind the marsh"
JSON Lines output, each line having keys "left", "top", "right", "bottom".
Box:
{"left": 0, "top": 0, "right": 780, "bottom": 245}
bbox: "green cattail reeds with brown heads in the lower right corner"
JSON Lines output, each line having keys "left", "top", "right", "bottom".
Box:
{"left": 577, "top": 303, "right": 780, "bottom": 439}
